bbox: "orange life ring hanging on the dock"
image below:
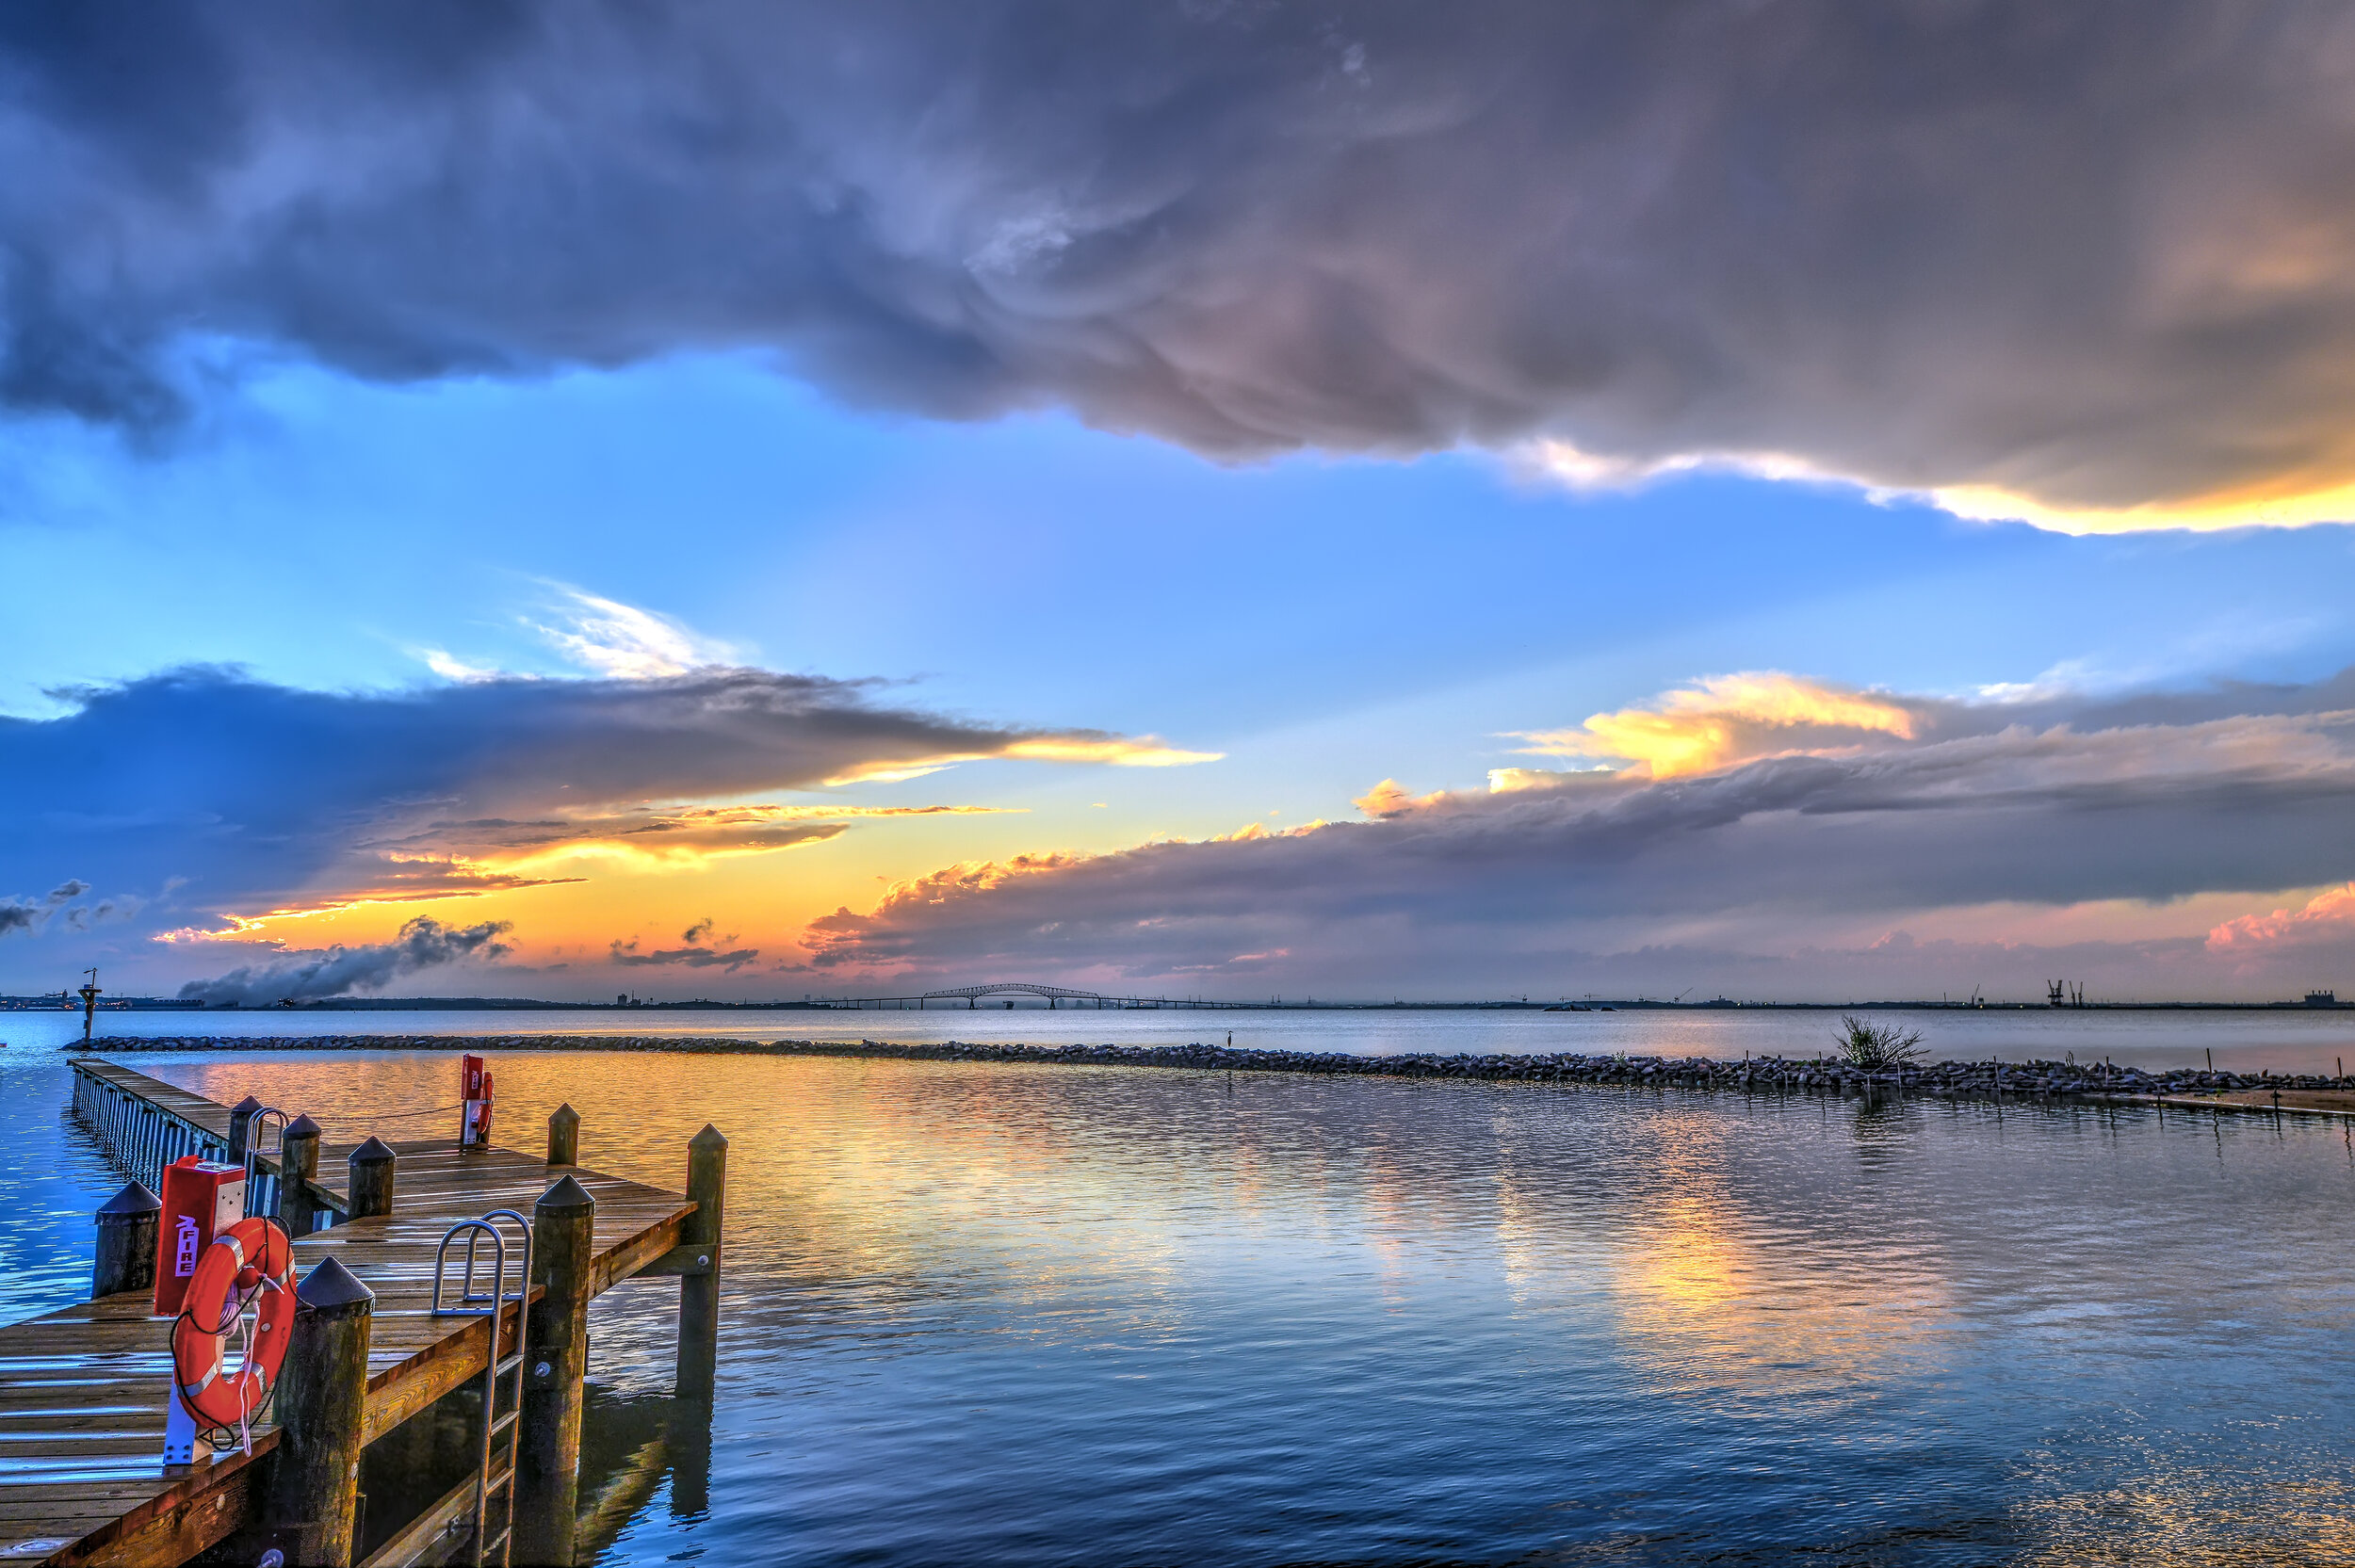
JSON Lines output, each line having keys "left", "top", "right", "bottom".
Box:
{"left": 172, "top": 1215, "right": 295, "bottom": 1431}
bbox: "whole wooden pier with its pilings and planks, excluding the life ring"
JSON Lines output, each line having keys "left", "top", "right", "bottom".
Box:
{"left": 0, "top": 1058, "right": 725, "bottom": 1568}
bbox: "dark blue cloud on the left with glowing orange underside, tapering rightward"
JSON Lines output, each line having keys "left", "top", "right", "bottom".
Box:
{"left": 0, "top": 669, "right": 1196, "bottom": 932}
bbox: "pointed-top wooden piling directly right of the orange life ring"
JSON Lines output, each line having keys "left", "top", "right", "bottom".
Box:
{"left": 264, "top": 1257, "right": 377, "bottom": 1568}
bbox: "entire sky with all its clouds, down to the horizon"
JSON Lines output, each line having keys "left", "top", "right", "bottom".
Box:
{"left": 13, "top": 0, "right": 2355, "bottom": 1003}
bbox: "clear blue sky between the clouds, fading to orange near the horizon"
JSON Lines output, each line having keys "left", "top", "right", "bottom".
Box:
{"left": 13, "top": 356, "right": 2355, "bottom": 994}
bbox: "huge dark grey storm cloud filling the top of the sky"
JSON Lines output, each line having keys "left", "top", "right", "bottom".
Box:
{"left": 0, "top": 0, "right": 2355, "bottom": 507}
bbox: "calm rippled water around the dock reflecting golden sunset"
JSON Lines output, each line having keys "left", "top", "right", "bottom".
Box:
{"left": 13, "top": 1015, "right": 2355, "bottom": 1563}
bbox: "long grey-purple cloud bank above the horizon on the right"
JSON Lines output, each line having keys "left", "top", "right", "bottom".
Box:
{"left": 805, "top": 676, "right": 2355, "bottom": 987}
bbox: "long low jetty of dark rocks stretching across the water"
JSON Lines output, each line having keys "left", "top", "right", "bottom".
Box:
{"left": 75, "top": 1034, "right": 2355, "bottom": 1097}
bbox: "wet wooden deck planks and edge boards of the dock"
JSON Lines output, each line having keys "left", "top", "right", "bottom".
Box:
{"left": 0, "top": 1062, "right": 695, "bottom": 1566}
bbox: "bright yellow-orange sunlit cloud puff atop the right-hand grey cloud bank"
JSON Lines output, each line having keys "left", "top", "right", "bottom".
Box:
{"left": 1505, "top": 671, "right": 1915, "bottom": 789}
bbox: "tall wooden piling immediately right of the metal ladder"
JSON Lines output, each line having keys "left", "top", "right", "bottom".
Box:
{"left": 513, "top": 1177, "right": 596, "bottom": 1563}
